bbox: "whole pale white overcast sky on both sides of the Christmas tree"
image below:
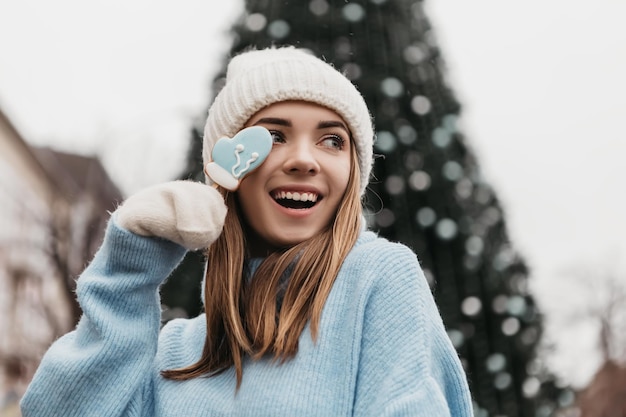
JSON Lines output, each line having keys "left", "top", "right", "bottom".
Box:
{"left": 0, "top": 0, "right": 626, "bottom": 384}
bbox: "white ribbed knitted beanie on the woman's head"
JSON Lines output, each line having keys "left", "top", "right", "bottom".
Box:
{"left": 202, "top": 47, "right": 374, "bottom": 194}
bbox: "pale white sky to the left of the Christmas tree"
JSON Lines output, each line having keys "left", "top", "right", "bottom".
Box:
{"left": 0, "top": 0, "right": 243, "bottom": 193}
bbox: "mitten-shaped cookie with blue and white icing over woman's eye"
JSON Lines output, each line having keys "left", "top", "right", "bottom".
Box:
{"left": 205, "top": 126, "right": 273, "bottom": 190}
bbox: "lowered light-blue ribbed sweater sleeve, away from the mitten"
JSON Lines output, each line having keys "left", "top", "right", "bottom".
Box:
{"left": 354, "top": 243, "right": 473, "bottom": 417}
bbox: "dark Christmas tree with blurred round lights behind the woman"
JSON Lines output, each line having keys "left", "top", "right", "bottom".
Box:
{"left": 164, "top": 0, "right": 572, "bottom": 417}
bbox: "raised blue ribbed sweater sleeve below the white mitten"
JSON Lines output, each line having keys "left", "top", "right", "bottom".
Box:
{"left": 21, "top": 218, "right": 185, "bottom": 417}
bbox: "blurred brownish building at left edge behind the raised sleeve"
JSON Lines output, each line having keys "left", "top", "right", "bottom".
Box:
{"left": 0, "top": 111, "right": 122, "bottom": 411}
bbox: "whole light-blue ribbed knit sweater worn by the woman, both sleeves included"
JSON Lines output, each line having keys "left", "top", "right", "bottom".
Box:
{"left": 21, "top": 220, "right": 472, "bottom": 417}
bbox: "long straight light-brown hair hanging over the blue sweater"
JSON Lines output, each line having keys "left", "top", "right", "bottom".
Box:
{"left": 162, "top": 146, "right": 362, "bottom": 387}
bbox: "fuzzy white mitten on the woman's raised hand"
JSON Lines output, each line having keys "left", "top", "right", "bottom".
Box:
{"left": 114, "top": 181, "right": 226, "bottom": 250}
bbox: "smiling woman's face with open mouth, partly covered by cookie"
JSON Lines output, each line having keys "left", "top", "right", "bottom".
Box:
{"left": 237, "top": 101, "right": 353, "bottom": 253}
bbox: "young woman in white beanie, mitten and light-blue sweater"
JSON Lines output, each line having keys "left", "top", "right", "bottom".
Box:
{"left": 21, "top": 47, "right": 472, "bottom": 417}
